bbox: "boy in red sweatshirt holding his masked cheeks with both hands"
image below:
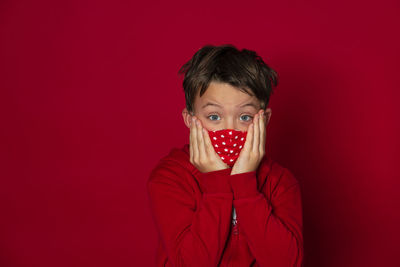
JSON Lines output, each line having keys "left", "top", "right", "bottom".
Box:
{"left": 147, "top": 45, "right": 303, "bottom": 267}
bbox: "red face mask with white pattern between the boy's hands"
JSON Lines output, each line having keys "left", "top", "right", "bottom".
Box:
{"left": 208, "top": 129, "right": 247, "bottom": 167}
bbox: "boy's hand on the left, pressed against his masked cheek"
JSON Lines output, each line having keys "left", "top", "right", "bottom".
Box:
{"left": 189, "top": 116, "right": 229, "bottom": 173}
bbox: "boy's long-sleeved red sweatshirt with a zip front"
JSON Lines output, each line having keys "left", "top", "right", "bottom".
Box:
{"left": 147, "top": 144, "right": 303, "bottom": 267}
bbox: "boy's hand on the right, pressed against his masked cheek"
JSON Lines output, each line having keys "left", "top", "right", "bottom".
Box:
{"left": 231, "top": 110, "right": 266, "bottom": 175}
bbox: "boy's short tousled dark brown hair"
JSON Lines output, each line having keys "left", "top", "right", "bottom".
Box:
{"left": 178, "top": 44, "right": 278, "bottom": 113}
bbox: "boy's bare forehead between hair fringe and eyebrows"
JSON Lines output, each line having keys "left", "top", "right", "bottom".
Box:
{"left": 194, "top": 81, "right": 260, "bottom": 109}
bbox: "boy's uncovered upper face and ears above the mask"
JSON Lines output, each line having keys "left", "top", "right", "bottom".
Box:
{"left": 182, "top": 82, "right": 271, "bottom": 131}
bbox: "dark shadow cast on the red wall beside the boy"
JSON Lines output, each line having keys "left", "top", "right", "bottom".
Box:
{"left": 267, "top": 54, "right": 358, "bottom": 267}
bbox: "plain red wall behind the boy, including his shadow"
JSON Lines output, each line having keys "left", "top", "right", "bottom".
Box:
{"left": 0, "top": 0, "right": 400, "bottom": 267}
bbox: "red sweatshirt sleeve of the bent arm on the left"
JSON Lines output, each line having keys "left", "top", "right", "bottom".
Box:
{"left": 147, "top": 163, "right": 233, "bottom": 267}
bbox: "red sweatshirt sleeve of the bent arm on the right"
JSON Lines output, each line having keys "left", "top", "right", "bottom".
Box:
{"left": 230, "top": 169, "right": 303, "bottom": 267}
